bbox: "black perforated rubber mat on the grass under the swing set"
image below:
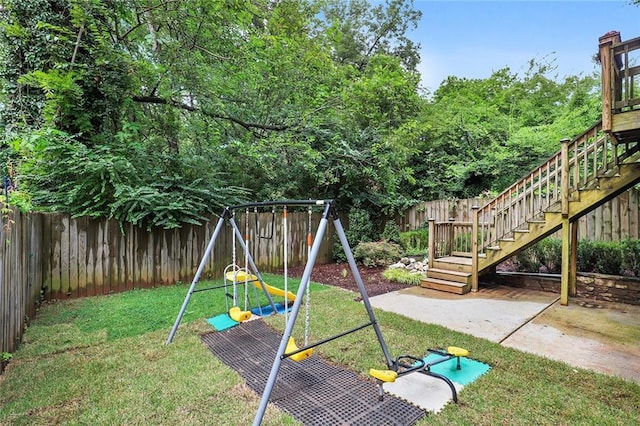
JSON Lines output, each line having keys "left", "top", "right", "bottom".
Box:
{"left": 202, "top": 320, "right": 426, "bottom": 426}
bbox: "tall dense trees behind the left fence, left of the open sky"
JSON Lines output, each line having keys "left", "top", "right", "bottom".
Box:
{"left": 0, "top": 0, "right": 428, "bottom": 233}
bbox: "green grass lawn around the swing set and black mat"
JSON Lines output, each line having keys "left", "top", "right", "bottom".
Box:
{"left": 0, "top": 274, "right": 640, "bottom": 425}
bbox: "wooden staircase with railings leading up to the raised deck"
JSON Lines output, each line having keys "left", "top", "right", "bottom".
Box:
{"left": 421, "top": 33, "right": 640, "bottom": 300}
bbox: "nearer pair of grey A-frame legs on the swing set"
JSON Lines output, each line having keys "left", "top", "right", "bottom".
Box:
{"left": 253, "top": 204, "right": 393, "bottom": 426}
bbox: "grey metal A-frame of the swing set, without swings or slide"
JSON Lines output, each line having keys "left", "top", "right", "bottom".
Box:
{"left": 166, "top": 200, "right": 395, "bottom": 426}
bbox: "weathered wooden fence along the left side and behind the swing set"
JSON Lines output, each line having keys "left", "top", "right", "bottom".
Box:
{"left": 0, "top": 206, "right": 334, "bottom": 360}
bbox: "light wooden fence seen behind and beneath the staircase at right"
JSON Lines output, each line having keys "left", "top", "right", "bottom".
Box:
{"left": 397, "top": 188, "right": 640, "bottom": 241}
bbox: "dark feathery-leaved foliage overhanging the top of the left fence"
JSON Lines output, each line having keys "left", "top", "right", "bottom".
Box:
{"left": 14, "top": 129, "right": 242, "bottom": 228}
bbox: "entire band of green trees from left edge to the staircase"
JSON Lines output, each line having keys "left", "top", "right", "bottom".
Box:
{"left": 0, "top": 0, "right": 599, "bottom": 235}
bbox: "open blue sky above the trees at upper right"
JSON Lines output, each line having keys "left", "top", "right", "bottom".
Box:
{"left": 409, "top": 0, "right": 640, "bottom": 91}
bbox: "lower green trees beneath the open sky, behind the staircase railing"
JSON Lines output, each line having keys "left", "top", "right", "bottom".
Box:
{"left": 402, "top": 62, "right": 600, "bottom": 199}
